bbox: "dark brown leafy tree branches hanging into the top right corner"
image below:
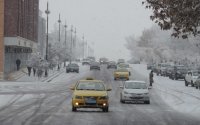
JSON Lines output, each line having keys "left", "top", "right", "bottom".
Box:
{"left": 142, "top": 0, "right": 200, "bottom": 39}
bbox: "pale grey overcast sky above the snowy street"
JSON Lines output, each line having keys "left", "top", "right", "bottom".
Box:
{"left": 40, "top": 0, "right": 153, "bottom": 60}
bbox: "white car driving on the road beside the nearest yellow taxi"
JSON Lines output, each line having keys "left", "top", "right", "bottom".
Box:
{"left": 120, "top": 80, "right": 150, "bottom": 104}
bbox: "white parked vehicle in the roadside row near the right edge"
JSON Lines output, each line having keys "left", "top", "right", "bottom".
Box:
{"left": 185, "top": 71, "right": 200, "bottom": 87}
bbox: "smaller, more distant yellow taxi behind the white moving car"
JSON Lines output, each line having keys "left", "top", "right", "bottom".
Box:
{"left": 114, "top": 68, "right": 130, "bottom": 80}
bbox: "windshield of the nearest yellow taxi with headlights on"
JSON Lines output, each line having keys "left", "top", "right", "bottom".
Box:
{"left": 76, "top": 82, "right": 105, "bottom": 91}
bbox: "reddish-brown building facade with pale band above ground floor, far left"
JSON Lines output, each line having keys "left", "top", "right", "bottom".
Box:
{"left": 0, "top": 0, "right": 39, "bottom": 78}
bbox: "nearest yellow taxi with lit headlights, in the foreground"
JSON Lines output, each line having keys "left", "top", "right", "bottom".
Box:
{"left": 71, "top": 78, "right": 111, "bottom": 112}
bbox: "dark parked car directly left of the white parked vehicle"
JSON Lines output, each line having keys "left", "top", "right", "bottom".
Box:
{"left": 169, "top": 65, "right": 188, "bottom": 80}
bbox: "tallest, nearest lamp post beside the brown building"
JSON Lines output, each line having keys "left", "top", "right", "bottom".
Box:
{"left": 45, "top": 2, "right": 50, "bottom": 77}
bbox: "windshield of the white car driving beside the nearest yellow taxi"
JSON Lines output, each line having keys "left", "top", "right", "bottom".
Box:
{"left": 125, "top": 82, "right": 147, "bottom": 89}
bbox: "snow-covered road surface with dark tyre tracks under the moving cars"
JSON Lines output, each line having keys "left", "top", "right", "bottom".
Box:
{"left": 0, "top": 65, "right": 200, "bottom": 125}
